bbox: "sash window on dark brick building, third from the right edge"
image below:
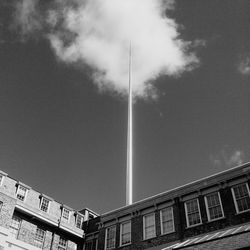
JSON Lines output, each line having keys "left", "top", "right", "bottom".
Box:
{"left": 185, "top": 199, "right": 201, "bottom": 227}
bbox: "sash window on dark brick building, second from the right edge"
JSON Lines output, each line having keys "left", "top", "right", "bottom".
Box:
{"left": 205, "top": 193, "right": 224, "bottom": 221}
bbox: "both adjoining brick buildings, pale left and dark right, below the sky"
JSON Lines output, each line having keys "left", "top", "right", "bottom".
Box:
{"left": 0, "top": 163, "right": 250, "bottom": 250}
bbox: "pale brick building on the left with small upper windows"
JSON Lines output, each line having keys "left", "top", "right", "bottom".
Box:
{"left": 0, "top": 171, "right": 97, "bottom": 250}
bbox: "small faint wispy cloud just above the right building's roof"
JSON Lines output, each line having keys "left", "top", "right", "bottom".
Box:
{"left": 210, "top": 146, "right": 245, "bottom": 168}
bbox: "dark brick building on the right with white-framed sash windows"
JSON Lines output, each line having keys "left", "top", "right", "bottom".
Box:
{"left": 84, "top": 163, "right": 250, "bottom": 250}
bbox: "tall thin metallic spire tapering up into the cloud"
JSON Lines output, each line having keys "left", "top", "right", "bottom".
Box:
{"left": 126, "top": 43, "right": 133, "bottom": 205}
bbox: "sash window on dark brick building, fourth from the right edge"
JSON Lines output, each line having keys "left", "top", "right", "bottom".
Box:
{"left": 160, "top": 207, "right": 174, "bottom": 234}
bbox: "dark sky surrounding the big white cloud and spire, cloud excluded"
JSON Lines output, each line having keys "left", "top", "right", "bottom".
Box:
{"left": 0, "top": 0, "right": 250, "bottom": 213}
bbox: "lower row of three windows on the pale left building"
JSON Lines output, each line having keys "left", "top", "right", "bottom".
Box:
{"left": 9, "top": 215, "right": 68, "bottom": 250}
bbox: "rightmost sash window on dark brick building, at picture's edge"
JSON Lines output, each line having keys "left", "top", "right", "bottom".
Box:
{"left": 232, "top": 183, "right": 250, "bottom": 213}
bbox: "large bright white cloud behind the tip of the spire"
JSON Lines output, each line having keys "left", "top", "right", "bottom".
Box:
{"left": 12, "top": 0, "right": 203, "bottom": 98}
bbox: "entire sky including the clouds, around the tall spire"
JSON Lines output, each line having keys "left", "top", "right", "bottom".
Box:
{"left": 0, "top": 0, "right": 250, "bottom": 213}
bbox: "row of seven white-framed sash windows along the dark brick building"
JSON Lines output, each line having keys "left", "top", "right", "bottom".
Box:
{"left": 105, "top": 183, "right": 250, "bottom": 249}
